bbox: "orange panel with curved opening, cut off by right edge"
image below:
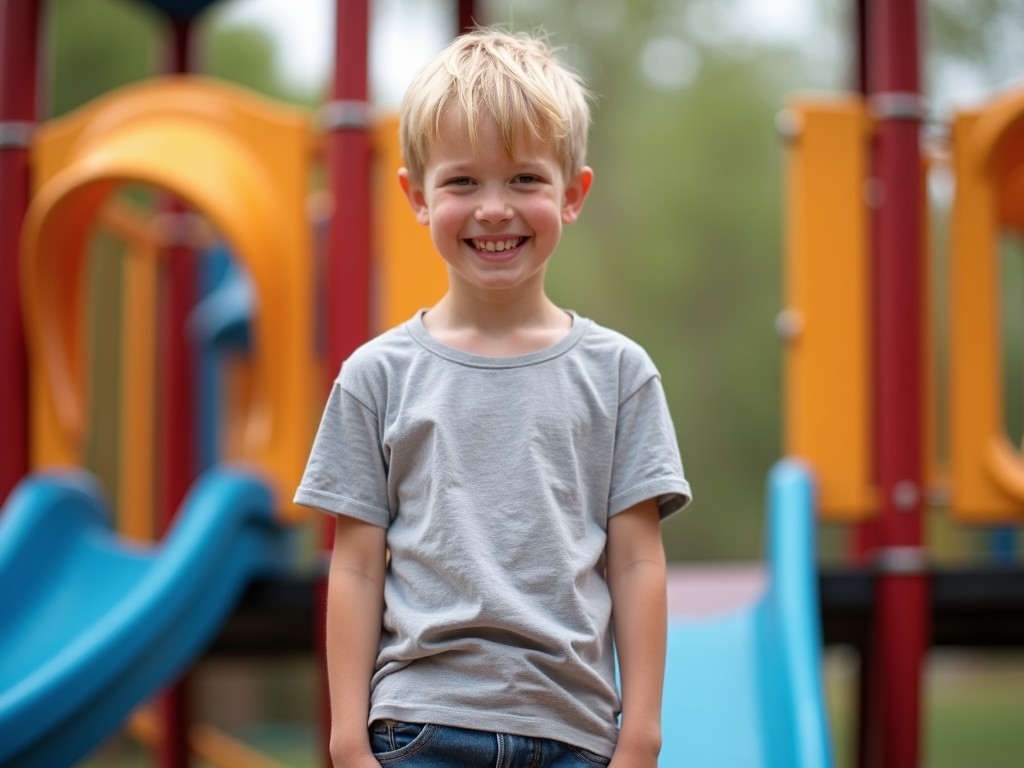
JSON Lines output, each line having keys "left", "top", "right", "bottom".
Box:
{"left": 949, "top": 91, "right": 1024, "bottom": 523}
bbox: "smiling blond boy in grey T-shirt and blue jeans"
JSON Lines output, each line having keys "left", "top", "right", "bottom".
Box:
{"left": 295, "top": 30, "right": 690, "bottom": 768}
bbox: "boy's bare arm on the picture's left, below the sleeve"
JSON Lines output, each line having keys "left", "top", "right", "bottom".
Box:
{"left": 327, "top": 515, "right": 386, "bottom": 768}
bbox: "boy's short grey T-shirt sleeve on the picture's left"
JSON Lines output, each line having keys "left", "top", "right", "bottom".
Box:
{"left": 295, "top": 382, "right": 390, "bottom": 527}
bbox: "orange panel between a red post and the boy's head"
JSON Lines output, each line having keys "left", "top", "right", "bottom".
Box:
{"left": 373, "top": 117, "right": 447, "bottom": 331}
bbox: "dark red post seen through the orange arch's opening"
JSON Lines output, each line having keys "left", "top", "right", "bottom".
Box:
{"left": 158, "top": 19, "right": 197, "bottom": 768}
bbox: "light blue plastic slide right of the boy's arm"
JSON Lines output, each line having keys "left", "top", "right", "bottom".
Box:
{"left": 660, "top": 461, "right": 833, "bottom": 768}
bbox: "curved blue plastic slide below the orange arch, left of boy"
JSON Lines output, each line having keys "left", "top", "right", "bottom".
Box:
{"left": 0, "top": 470, "right": 281, "bottom": 768}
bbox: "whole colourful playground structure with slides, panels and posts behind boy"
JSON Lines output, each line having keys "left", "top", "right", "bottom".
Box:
{"left": 0, "top": 0, "right": 1024, "bottom": 768}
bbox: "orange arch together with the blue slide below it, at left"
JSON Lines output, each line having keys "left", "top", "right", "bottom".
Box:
{"left": 0, "top": 67, "right": 315, "bottom": 766}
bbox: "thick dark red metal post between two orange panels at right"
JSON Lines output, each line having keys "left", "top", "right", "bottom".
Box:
{"left": 862, "top": 0, "right": 929, "bottom": 768}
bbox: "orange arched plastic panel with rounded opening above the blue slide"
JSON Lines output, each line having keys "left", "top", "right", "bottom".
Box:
{"left": 22, "top": 78, "right": 315, "bottom": 517}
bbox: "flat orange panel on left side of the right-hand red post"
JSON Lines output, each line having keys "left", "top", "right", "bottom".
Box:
{"left": 779, "top": 96, "right": 874, "bottom": 520}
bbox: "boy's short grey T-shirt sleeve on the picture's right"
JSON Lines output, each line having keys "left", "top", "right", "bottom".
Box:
{"left": 608, "top": 376, "right": 691, "bottom": 519}
